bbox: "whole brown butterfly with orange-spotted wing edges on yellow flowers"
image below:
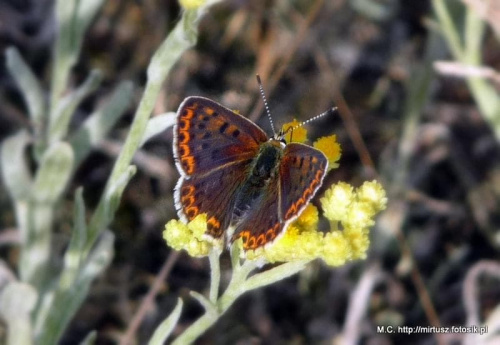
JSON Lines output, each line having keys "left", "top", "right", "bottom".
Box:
{"left": 173, "top": 90, "right": 328, "bottom": 250}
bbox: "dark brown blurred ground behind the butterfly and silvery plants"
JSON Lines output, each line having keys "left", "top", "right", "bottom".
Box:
{"left": 0, "top": 0, "right": 500, "bottom": 345}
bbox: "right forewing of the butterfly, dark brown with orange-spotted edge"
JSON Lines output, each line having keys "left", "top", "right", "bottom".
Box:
{"left": 279, "top": 143, "right": 328, "bottom": 221}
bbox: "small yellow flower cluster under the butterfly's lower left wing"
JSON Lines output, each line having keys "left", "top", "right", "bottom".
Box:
{"left": 163, "top": 214, "right": 222, "bottom": 257}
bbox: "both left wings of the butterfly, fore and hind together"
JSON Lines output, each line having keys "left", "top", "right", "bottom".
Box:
{"left": 174, "top": 97, "right": 267, "bottom": 238}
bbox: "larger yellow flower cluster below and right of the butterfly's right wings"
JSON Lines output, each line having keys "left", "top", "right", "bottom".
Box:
{"left": 246, "top": 181, "right": 387, "bottom": 266}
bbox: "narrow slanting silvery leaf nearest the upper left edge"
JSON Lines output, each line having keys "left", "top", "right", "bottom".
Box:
{"left": 5, "top": 47, "right": 46, "bottom": 133}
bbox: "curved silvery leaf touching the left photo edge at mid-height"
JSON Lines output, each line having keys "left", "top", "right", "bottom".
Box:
{"left": 1, "top": 131, "right": 32, "bottom": 200}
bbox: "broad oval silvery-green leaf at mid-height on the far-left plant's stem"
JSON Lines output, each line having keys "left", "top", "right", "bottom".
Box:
{"left": 33, "top": 142, "right": 73, "bottom": 203}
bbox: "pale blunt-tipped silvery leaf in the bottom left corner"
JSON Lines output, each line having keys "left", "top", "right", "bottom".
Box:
{"left": 0, "top": 282, "right": 37, "bottom": 345}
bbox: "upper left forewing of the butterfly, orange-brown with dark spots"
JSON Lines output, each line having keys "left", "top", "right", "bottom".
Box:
{"left": 174, "top": 97, "right": 267, "bottom": 176}
